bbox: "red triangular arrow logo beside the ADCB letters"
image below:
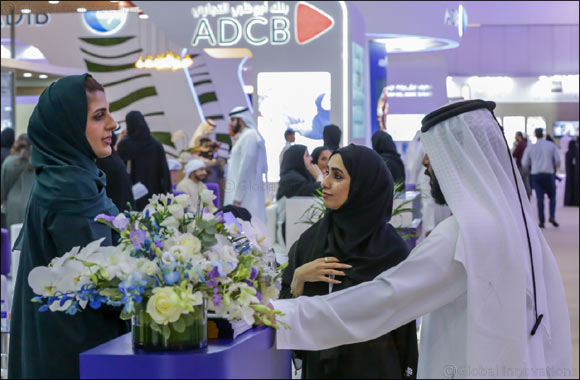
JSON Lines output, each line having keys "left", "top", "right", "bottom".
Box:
{"left": 294, "top": 1, "right": 334, "bottom": 45}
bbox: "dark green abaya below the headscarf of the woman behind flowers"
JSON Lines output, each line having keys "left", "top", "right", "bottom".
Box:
{"left": 9, "top": 203, "right": 129, "bottom": 379}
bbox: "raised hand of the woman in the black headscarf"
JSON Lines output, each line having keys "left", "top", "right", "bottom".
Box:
{"left": 290, "top": 256, "right": 352, "bottom": 297}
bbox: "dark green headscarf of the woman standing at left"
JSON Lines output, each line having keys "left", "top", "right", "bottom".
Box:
{"left": 28, "top": 74, "right": 118, "bottom": 218}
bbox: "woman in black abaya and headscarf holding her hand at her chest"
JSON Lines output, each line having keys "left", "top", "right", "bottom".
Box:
{"left": 280, "top": 144, "right": 418, "bottom": 379}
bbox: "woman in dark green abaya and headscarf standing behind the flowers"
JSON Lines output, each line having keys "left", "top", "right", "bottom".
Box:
{"left": 8, "top": 74, "right": 128, "bottom": 379}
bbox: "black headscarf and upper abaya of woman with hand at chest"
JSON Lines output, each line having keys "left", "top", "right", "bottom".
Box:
{"left": 285, "top": 144, "right": 408, "bottom": 290}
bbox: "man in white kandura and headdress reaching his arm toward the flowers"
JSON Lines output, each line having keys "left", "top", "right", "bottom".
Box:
{"left": 273, "top": 100, "right": 573, "bottom": 378}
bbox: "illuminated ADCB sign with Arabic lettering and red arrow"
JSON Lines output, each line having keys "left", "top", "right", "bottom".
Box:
{"left": 191, "top": 1, "right": 334, "bottom": 46}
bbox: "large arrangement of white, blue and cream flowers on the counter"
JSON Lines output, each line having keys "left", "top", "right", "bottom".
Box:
{"left": 28, "top": 190, "right": 287, "bottom": 339}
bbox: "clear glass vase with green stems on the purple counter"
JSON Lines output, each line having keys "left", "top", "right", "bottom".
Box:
{"left": 131, "top": 299, "right": 207, "bottom": 351}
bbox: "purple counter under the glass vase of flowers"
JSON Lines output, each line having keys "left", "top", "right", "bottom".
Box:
{"left": 80, "top": 327, "right": 292, "bottom": 379}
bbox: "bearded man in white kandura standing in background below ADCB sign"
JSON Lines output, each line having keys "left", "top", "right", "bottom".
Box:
{"left": 224, "top": 107, "right": 268, "bottom": 224}
